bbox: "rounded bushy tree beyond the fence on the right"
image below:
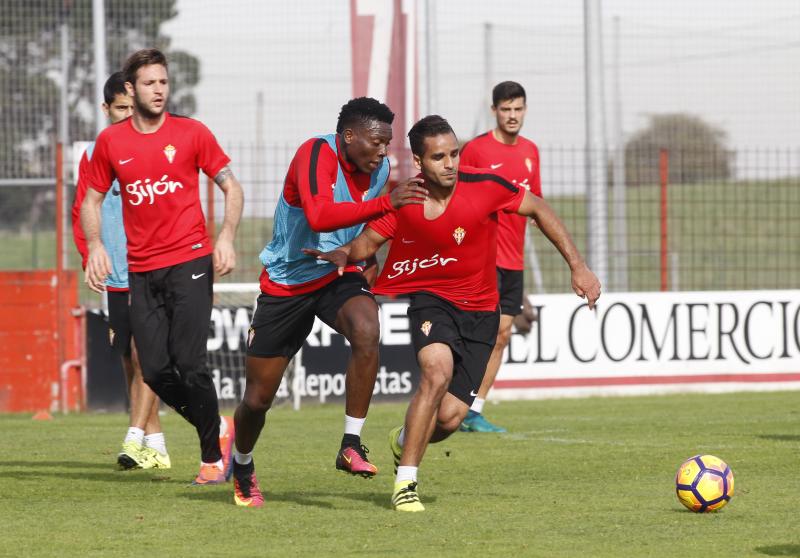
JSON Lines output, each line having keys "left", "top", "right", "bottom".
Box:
{"left": 625, "top": 113, "right": 731, "bottom": 186}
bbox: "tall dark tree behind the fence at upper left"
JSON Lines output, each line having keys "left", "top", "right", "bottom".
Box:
{"left": 0, "top": 0, "right": 200, "bottom": 228}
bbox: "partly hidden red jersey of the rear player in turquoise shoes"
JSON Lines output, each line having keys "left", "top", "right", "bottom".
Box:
{"left": 461, "top": 132, "right": 542, "bottom": 270}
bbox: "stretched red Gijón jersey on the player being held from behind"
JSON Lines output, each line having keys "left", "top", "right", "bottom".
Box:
{"left": 368, "top": 165, "right": 525, "bottom": 311}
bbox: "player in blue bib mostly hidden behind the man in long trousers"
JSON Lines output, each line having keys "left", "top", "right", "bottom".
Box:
{"left": 72, "top": 72, "right": 170, "bottom": 469}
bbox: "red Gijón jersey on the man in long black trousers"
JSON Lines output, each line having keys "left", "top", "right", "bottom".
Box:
{"left": 89, "top": 113, "right": 230, "bottom": 272}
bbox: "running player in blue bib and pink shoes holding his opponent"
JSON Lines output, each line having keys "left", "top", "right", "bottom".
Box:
{"left": 233, "top": 97, "right": 425, "bottom": 507}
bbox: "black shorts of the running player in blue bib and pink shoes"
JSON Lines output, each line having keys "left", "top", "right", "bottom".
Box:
{"left": 247, "top": 272, "right": 375, "bottom": 358}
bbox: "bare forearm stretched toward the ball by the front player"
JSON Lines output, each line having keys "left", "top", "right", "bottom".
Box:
{"left": 517, "top": 192, "right": 600, "bottom": 309}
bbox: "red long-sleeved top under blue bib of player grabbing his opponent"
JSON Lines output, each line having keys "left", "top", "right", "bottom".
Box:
{"left": 259, "top": 138, "right": 394, "bottom": 296}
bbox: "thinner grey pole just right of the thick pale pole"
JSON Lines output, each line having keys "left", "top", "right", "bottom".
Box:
{"left": 612, "top": 17, "right": 628, "bottom": 291}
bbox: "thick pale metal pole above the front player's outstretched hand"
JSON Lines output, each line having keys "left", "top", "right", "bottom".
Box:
{"left": 583, "top": 0, "right": 608, "bottom": 285}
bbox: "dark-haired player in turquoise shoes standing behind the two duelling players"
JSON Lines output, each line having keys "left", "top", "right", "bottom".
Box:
{"left": 461, "top": 81, "right": 542, "bottom": 432}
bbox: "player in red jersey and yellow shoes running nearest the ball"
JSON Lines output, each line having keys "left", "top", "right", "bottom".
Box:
{"left": 306, "top": 115, "right": 600, "bottom": 512}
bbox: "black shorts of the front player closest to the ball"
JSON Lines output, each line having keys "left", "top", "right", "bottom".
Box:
{"left": 408, "top": 293, "right": 500, "bottom": 405}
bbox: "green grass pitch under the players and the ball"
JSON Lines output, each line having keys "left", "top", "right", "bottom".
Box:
{"left": 0, "top": 392, "right": 800, "bottom": 558}
